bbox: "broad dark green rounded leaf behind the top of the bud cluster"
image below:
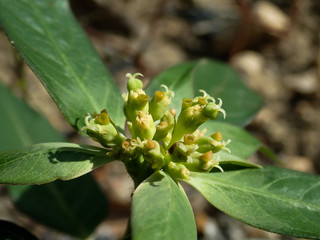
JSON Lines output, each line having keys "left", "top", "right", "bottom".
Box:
{"left": 146, "top": 59, "right": 262, "bottom": 126}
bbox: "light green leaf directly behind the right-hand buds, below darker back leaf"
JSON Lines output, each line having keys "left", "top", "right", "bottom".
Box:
{"left": 201, "top": 121, "right": 261, "bottom": 159}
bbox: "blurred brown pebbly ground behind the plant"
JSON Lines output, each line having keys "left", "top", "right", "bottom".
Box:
{"left": 0, "top": 0, "right": 320, "bottom": 240}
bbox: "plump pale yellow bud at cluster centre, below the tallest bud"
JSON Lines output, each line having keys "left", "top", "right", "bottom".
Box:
{"left": 132, "top": 111, "right": 156, "bottom": 139}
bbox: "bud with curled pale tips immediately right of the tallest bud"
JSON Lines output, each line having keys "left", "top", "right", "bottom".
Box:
{"left": 149, "top": 85, "right": 174, "bottom": 121}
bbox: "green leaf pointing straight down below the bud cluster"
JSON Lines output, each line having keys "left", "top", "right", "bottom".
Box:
{"left": 131, "top": 171, "right": 197, "bottom": 240}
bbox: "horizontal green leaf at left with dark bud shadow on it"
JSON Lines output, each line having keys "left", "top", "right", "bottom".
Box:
{"left": 0, "top": 143, "right": 113, "bottom": 184}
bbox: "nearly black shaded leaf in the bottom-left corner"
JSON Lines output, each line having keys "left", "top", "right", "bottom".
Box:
{"left": 0, "top": 220, "right": 37, "bottom": 240}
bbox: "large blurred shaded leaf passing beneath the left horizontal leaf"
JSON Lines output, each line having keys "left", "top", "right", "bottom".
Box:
{"left": 0, "top": 85, "right": 107, "bottom": 236}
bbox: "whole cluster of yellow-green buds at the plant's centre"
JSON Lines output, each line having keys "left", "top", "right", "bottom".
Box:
{"left": 83, "top": 73, "right": 230, "bottom": 182}
